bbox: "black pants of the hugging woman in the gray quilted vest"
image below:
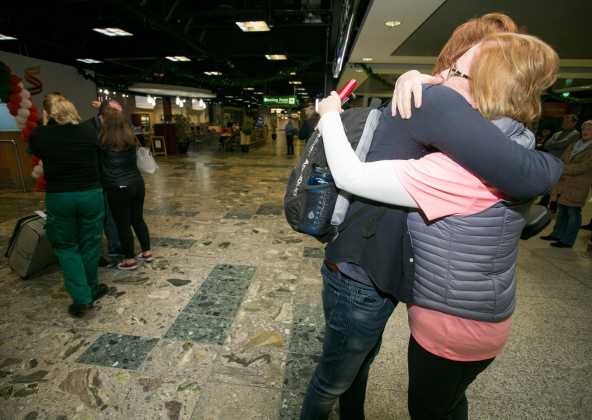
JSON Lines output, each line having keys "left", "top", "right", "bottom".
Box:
{"left": 407, "top": 336, "right": 493, "bottom": 420}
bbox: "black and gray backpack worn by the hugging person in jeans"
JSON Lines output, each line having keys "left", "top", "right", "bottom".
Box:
{"left": 284, "top": 108, "right": 381, "bottom": 243}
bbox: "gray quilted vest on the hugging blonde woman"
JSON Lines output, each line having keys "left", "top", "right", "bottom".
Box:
{"left": 407, "top": 203, "right": 526, "bottom": 322}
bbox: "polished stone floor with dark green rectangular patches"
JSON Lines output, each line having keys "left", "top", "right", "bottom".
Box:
{"left": 0, "top": 131, "right": 592, "bottom": 420}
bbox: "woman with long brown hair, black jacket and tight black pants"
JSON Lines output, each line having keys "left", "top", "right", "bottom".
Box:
{"left": 99, "top": 108, "right": 154, "bottom": 270}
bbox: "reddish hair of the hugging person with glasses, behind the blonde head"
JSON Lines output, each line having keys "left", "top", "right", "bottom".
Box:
{"left": 432, "top": 13, "right": 518, "bottom": 74}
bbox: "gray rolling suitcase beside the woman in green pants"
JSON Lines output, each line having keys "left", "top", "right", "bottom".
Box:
{"left": 4, "top": 214, "right": 57, "bottom": 279}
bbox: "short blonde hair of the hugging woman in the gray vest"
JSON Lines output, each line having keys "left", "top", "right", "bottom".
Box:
{"left": 470, "top": 33, "right": 559, "bottom": 123}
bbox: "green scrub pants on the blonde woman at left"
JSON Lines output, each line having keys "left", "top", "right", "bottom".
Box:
{"left": 45, "top": 188, "right": 105, "bottom": 304}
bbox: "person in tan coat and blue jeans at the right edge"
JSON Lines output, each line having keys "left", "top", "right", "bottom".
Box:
{"left": 541, "top": 120, "right": 592, "bottom": 248}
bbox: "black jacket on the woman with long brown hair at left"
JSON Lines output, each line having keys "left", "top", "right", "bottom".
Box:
{"left": 99, "top": 147, "right": 142, "bottom": 190}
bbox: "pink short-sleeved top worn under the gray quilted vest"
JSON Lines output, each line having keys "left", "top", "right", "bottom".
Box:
{"left": 395, "top": 153, "right": 512, "bottom": 361}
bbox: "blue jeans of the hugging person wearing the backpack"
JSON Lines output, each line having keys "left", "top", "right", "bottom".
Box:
{"left": 300, "top": 265, "right": 398, "bottom": 420}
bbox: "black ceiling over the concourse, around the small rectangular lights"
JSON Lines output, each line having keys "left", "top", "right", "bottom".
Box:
{"left": 0, "top": 0, "right": 368, "bottom": 105}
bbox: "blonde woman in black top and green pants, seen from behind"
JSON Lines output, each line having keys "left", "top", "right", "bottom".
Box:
{"left": 29, "top": 94, "right": 109, "bottom": 318}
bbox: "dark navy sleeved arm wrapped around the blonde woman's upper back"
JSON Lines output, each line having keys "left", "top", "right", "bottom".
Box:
{"left": 406, "top": 86, "right": 563, "bottom": 200}
